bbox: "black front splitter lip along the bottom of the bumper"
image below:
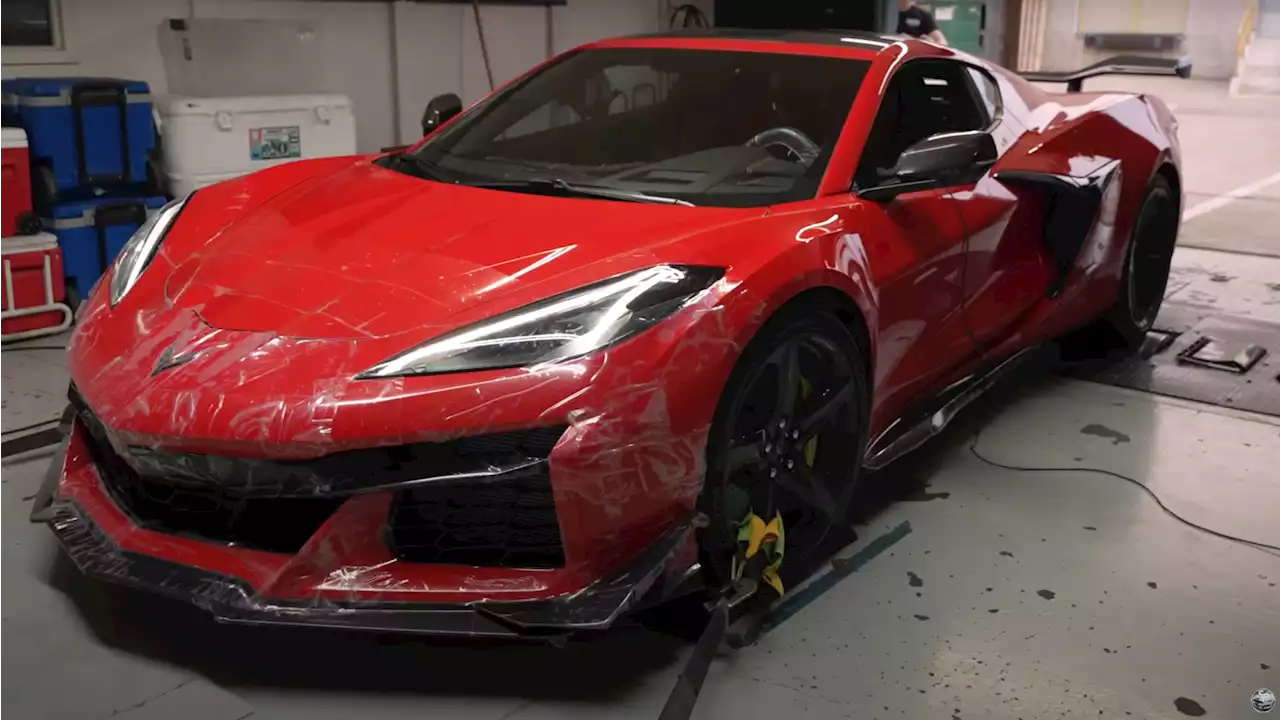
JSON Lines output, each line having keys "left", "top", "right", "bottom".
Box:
{"left": 31, "top": 437, "right": 700, "bottom": 638}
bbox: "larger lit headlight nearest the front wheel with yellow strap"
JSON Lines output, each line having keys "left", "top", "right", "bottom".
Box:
{"left": 358, "top": 265, "right": 724, "bottom": 379}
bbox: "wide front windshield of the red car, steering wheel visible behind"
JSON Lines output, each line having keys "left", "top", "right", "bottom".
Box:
{"left": 397, "top": 47, "right": 868, "bottom": 208}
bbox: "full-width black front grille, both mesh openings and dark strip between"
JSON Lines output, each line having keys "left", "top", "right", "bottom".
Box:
{"left": 70, "top": 388, "right": 564, "bottom": 558}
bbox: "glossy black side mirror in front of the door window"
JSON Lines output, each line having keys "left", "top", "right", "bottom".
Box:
{"left": 858, "top": 131, "right": 998, "bottom": 201}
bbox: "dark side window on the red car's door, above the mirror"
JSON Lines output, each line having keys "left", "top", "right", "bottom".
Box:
{"left": 854, "top": 59, "right": 995, "bottom": 187}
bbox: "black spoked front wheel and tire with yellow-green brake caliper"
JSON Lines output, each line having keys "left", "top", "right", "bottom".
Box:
{"left": 699, "top": 302, "right": 868, "bottom": 588}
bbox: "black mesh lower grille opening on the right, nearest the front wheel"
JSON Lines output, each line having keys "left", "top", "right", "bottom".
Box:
{"left": 388, "top": 465, "right": 564, "bottom": 569}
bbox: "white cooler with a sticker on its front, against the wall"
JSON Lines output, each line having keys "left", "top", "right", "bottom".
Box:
{"left": 156, "top": 95, "right": 356, "bottom": 197}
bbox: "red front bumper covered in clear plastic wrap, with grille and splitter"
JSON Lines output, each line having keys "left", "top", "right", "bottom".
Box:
{"left": 32, "top": 242, "right": 740, "bottom": 635}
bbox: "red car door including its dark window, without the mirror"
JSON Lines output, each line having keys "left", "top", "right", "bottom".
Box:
{"left": 854, "top": 59, "right": 987, "bottom": 418}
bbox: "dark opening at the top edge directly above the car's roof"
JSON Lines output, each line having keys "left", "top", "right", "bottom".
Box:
{"left": 716, "top": 0, "right": 882, "bottom": 32}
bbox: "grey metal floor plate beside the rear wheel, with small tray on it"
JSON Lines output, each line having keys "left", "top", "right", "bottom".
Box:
{"left": 1069, "top": 302, "right": 1280, "bottom": 416}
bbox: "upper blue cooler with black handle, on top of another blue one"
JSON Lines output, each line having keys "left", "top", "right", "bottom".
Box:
{"left": 0, "top": 78, "right": 155, "bottom": 211}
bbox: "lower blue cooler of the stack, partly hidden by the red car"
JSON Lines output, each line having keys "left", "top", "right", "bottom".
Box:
{"left": 44, "top": 197, "right": 168, "bottom": 300}
